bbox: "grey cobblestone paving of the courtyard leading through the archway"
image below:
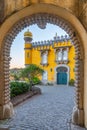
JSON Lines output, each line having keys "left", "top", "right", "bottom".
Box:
{"left": 0, "top": 86, "right": 85, "bottom": 130}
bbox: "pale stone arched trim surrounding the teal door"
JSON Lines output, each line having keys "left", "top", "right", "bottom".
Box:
{"left": 54, "top": 64, "right": 70, "bottom": 85}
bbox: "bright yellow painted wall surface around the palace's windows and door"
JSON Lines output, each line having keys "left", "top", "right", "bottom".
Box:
{"left": 25, "top": 41, "right": 75, "bottom": 81}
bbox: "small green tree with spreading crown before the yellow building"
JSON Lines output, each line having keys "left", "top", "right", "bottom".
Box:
{"left": 21, "top": 64, "right": 44, "bottom": 88}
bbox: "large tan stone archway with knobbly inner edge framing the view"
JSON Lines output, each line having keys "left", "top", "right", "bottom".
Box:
{"left": 0, "top": 4, "right": 87, "bottom": 127}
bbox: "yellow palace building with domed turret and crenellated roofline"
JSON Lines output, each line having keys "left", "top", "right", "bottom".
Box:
{"left": 24, "top": 31, "right": 75, "bottom": 85}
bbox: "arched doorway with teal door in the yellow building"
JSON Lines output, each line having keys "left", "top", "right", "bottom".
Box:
{"left": 56, "top": 65, "right": 69, "bottom": 85}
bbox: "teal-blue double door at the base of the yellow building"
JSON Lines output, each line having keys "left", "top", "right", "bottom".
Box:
{"left": 57, "top": 72, "right": 67, "bottom": 85}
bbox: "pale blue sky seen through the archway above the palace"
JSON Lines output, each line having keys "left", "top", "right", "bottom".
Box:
{"left": 10, "top": 24, "right": 66, "bottom": 68}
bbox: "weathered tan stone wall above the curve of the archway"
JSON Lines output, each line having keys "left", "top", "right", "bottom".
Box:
{"left": 0, "top": 0, "right": 87, "bottom": 30}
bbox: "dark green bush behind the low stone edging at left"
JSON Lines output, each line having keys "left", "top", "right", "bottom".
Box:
{"left": 10, "top": 82, "right": 30, "bottom": 98}
